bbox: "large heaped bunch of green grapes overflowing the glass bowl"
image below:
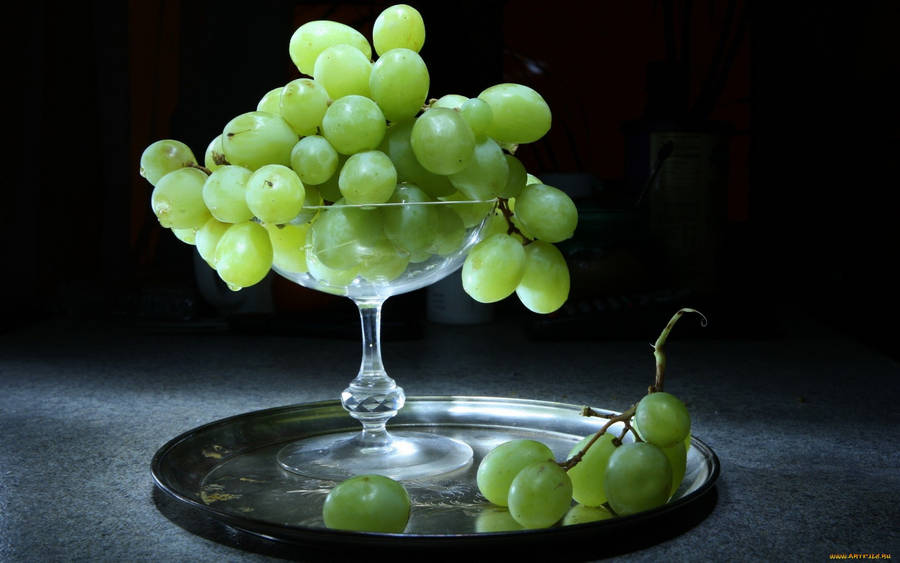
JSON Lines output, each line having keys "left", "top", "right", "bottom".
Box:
{"left": 141, "top": 4, "right": 578, "bottom": 313}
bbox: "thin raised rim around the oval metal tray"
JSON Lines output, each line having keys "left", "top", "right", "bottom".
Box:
{"left": 150, "top": 395, "right": 721, "bottom": 547}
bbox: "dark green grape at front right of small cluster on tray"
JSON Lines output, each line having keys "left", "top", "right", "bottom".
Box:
{"left": 603, "top": 442, "right": 672, "bottom": 516}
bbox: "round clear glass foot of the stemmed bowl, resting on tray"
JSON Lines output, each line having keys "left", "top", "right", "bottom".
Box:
{"left": 277, "top": 431, "right": 472, "bottom": 481}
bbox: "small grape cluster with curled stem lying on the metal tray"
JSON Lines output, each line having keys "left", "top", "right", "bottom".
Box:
{"left": 477, "top": 309, "right": 705, "bottom": 528}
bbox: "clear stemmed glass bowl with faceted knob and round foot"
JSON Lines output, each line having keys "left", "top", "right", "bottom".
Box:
{"left": 273, "top": 197, "right": 495, "bottom": 480}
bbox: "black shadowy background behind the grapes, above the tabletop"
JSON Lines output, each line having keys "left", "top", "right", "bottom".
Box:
{"left": 8, "top": 0, "right": 900, "bottom": 354}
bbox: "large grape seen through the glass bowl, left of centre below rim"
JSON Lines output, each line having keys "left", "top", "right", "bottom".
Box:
{"left": 311, "top": 205, "right": 385, "bottom": 271}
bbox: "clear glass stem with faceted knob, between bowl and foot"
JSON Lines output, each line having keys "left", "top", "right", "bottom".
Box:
{"left": 341, "top": 299, "right": 406, "bottom": 448}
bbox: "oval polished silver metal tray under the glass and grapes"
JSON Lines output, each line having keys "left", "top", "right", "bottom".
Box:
{"left": 152, "top": 396, "right": 719, "bottom": 550}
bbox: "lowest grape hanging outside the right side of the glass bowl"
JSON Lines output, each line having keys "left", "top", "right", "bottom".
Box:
{"left": 516, "top": 240, "right": 570, "bottom": 314}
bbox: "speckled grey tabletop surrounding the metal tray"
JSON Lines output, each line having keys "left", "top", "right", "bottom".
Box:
{"left": 0, "top": 310, "right": 900, "bottom": 562}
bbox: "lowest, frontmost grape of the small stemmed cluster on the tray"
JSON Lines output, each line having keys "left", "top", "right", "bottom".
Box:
{"left": 509, "top": 460, "right": 572, "bottom": 528}
